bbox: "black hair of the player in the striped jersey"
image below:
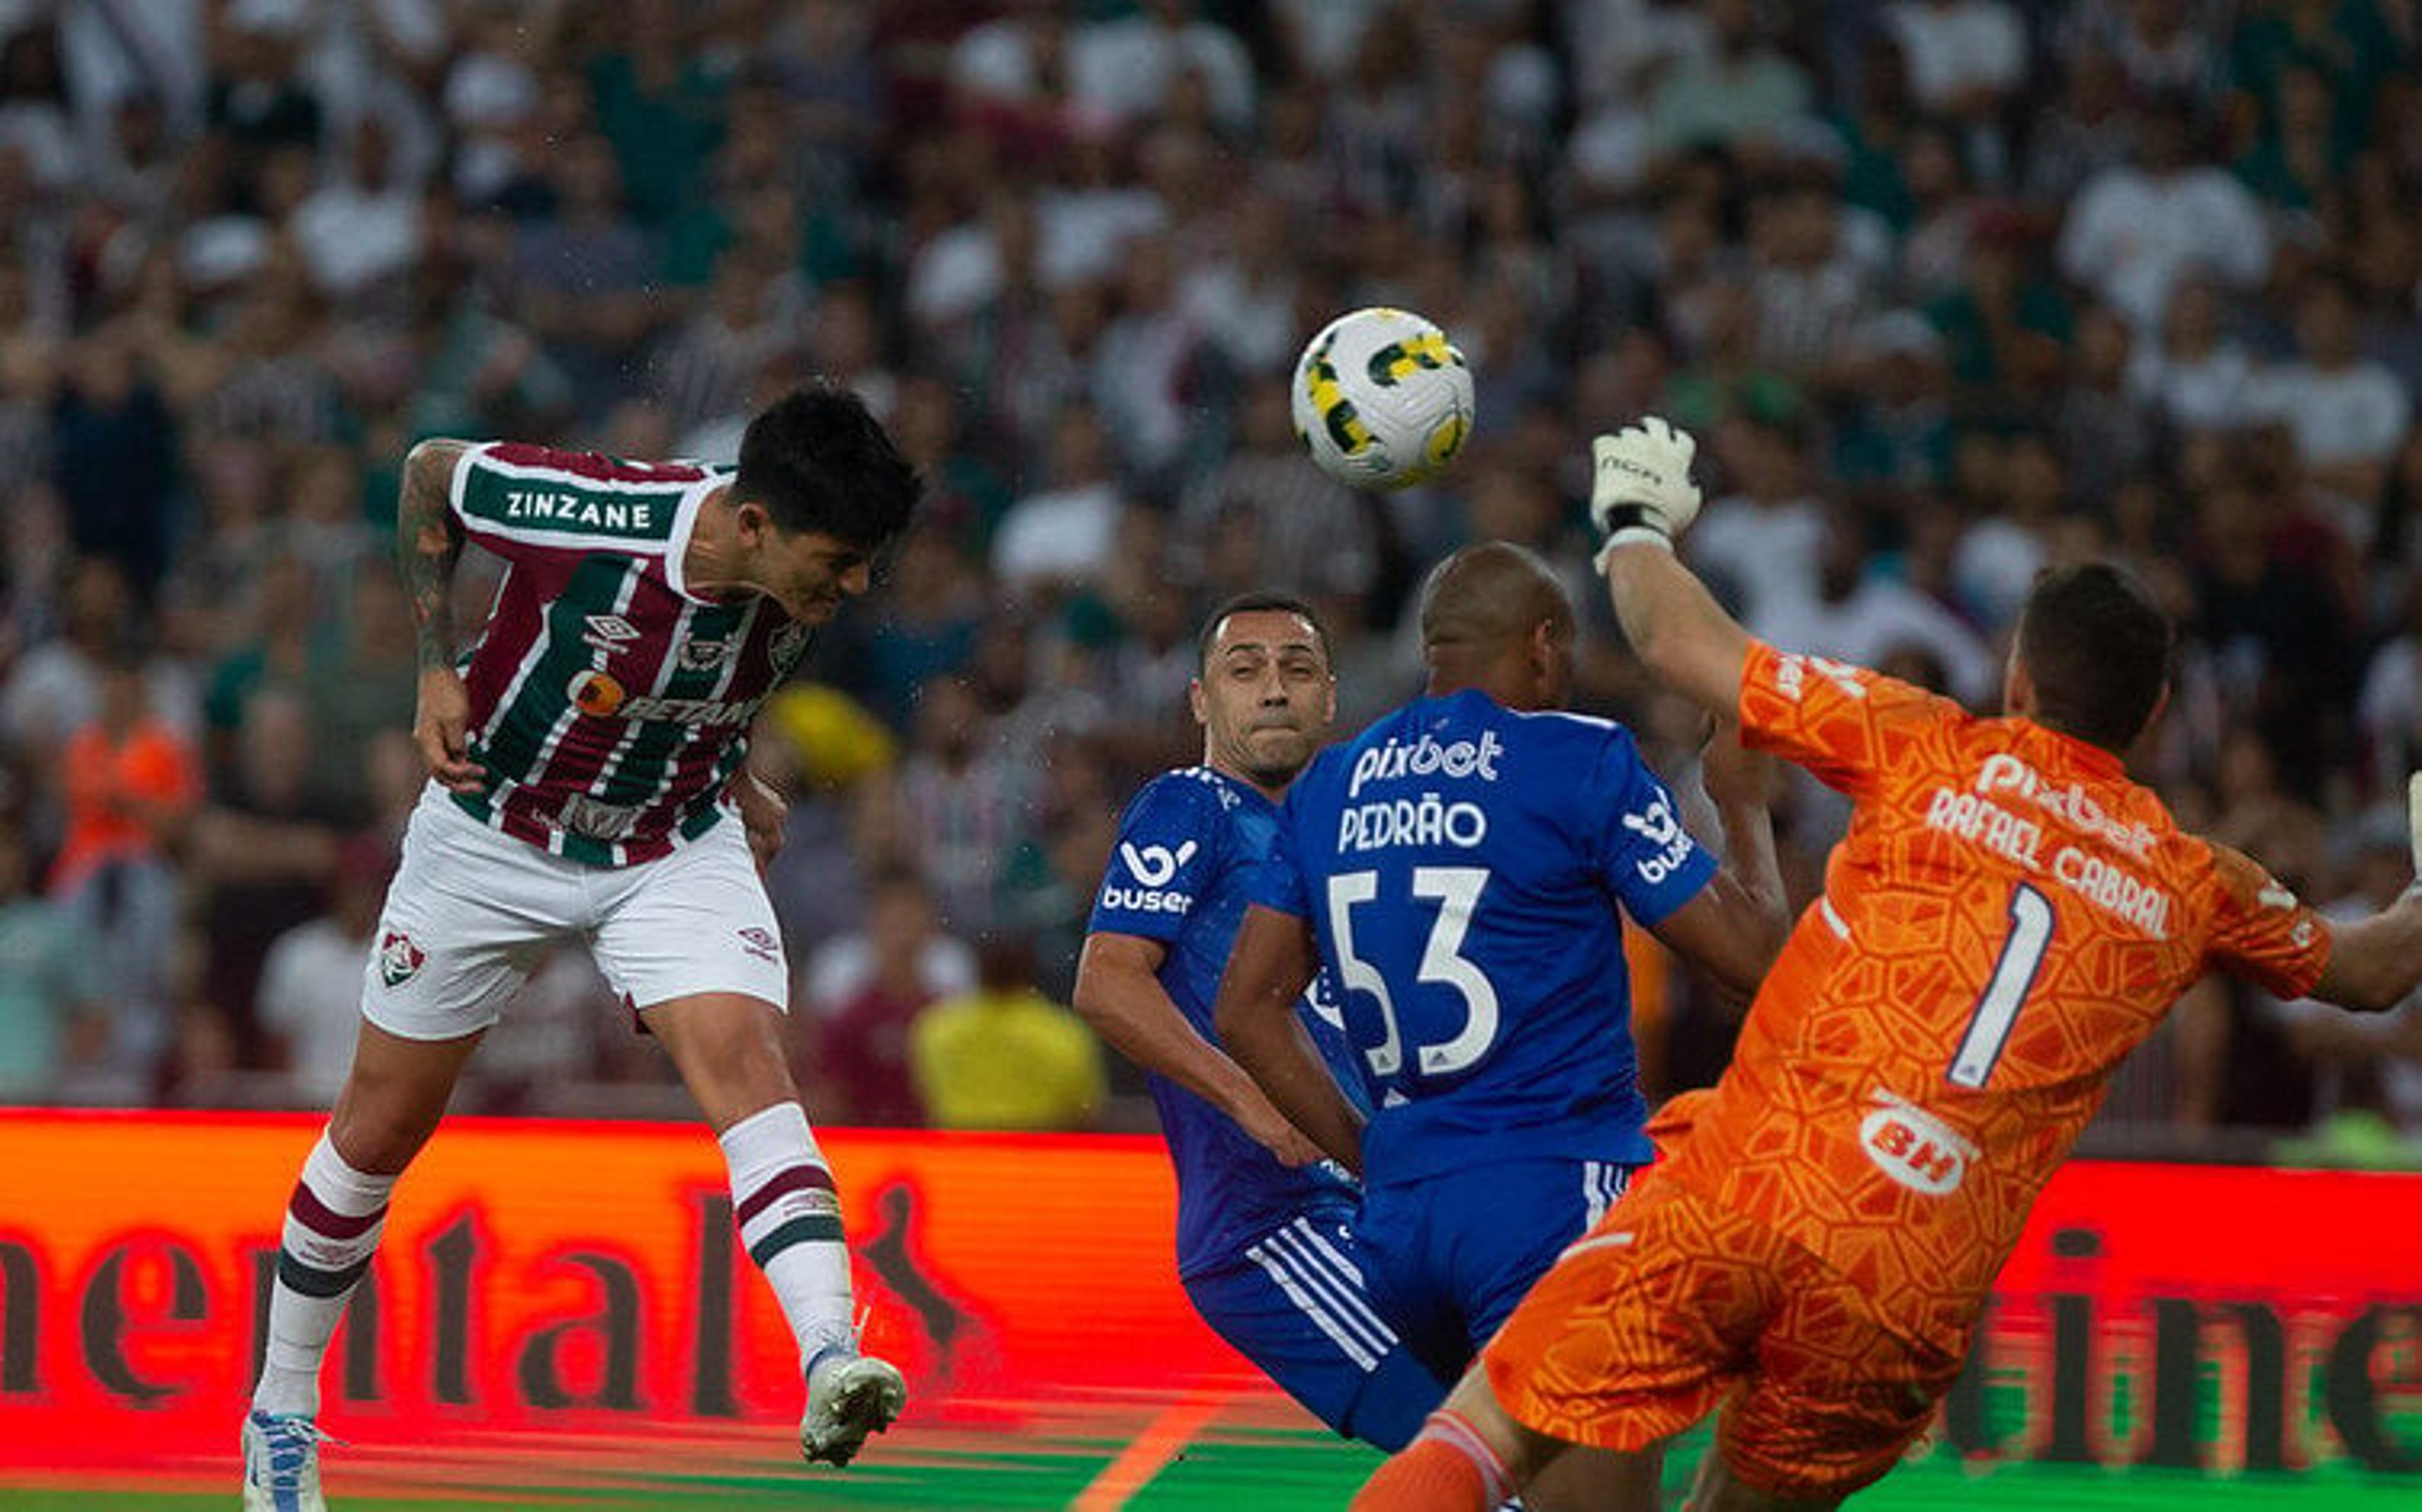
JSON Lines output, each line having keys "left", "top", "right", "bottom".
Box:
{"left": 732, "top": 383, "right": 925, "bottom": 550}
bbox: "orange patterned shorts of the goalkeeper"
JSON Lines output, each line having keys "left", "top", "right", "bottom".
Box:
{"left": 1482, "top": 1175, "right": 1960, "bottom": 1497}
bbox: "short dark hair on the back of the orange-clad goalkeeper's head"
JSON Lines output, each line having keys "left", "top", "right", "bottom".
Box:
{"left": 2018, "top": 562, "right": 2170, "bottom": 751}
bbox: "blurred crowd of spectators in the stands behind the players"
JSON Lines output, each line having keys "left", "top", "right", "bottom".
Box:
{"left": 0, "top": 0, "right": 2422, "bottom": 1149}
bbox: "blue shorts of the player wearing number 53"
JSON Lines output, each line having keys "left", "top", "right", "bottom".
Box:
{"left": 1354, "top": 1158, "right": 1635, "bottom": 1381}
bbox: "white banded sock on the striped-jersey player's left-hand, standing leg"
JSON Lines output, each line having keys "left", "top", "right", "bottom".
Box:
{"left": 252, "top": 1129, "right": 395, "bottom": 1415}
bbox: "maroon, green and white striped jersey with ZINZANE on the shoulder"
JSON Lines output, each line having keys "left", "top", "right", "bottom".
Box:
{"left": 448, "top": 441, "right": 809, "bottom": 868}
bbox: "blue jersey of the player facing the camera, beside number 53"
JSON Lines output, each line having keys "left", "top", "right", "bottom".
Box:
{"left": 1090, "top": 765, "right": 1354, "bottom": 1277}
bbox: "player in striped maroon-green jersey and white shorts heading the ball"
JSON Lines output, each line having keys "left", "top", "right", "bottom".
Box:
{"left": 245, "top": 388, "right": 920, "bottom": 1512}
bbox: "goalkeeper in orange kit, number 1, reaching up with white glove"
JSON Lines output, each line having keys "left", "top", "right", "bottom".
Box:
{"left": 1354, "top": 419, "right": 2422, "bottom": 1512}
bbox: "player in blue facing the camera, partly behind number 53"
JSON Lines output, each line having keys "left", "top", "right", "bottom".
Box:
{"left": 1075, "top": 594, "right": 1453, "bottom": 1449}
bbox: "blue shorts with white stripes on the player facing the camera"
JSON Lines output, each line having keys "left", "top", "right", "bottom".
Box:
{"left": 1182, "top": 1209, "right": 1451, "bottom": 1454}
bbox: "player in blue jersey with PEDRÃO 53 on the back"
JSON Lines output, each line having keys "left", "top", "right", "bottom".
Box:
{"left": 1216, "top": 543, "right": 1787, "bottom": 1507}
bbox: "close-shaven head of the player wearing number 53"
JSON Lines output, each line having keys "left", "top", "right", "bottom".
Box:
{"left": 1422, "top": 540, "right": 1574, "bottom": 710}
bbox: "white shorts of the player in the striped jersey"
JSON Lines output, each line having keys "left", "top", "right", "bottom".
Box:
{"left": 361, "top": 785, "right": 790, "bottom": 1040}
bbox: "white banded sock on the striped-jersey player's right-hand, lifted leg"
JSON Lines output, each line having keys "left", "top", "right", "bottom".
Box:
{"left": 719, "top": 1103, "right": 857, "bottom": 1369}
